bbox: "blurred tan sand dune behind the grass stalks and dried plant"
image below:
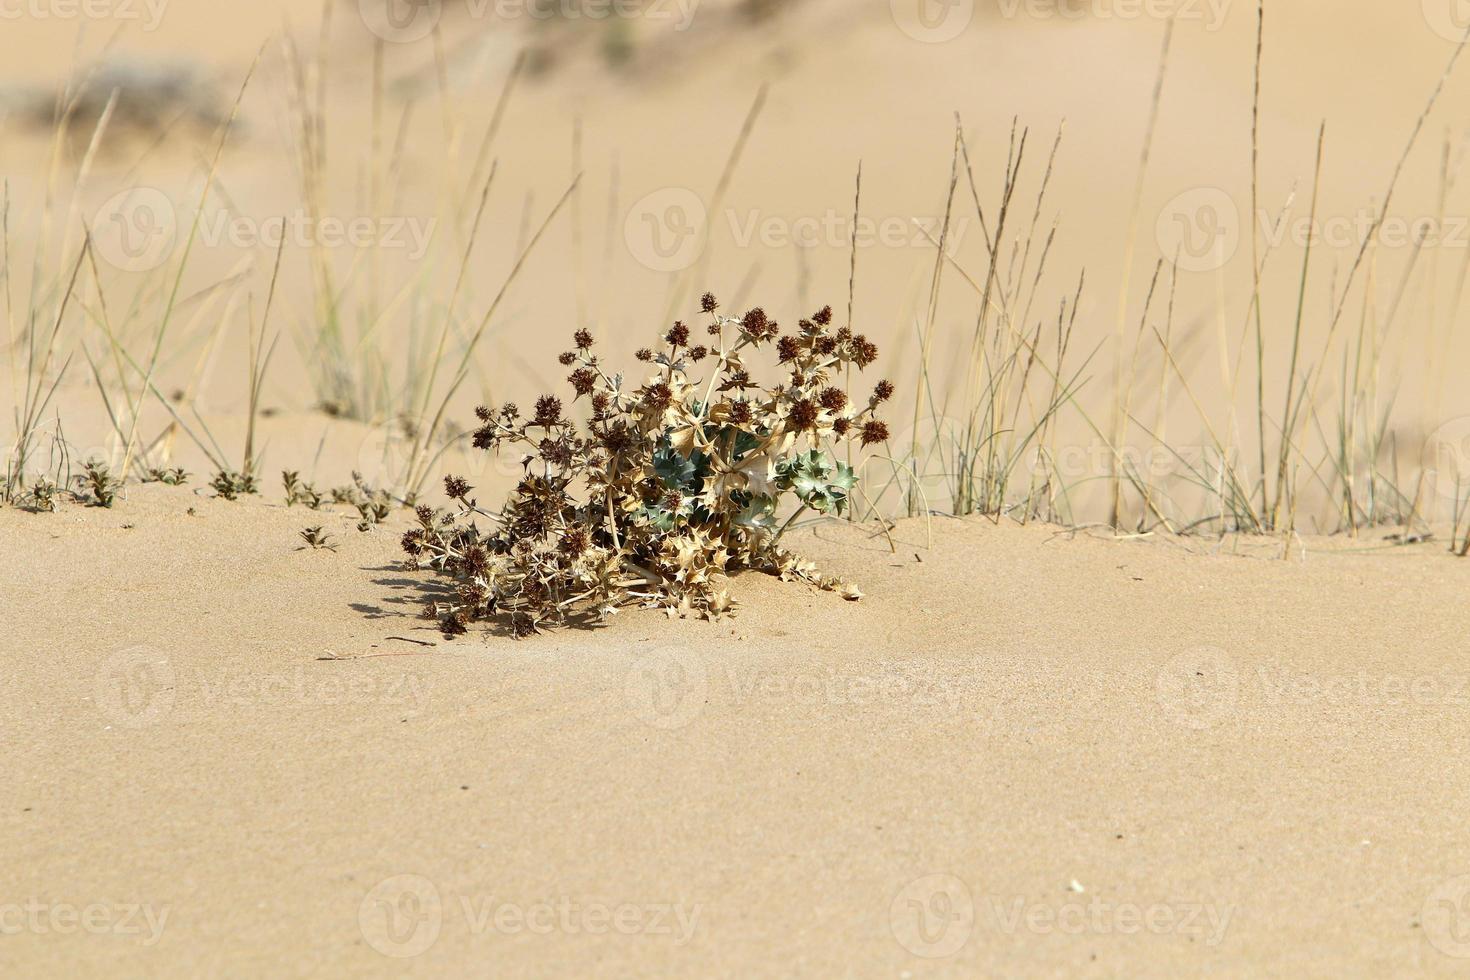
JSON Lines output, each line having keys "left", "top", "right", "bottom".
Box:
{"left": 0, "top": 0, "right": 1470, "bottom": 527}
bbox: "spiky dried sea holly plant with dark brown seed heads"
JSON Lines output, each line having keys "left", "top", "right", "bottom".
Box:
{"left": 403, "top": 295, "right": 894, "bottom": 636}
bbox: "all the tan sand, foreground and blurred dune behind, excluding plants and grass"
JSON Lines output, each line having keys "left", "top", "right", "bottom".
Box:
{"left": 0, "top": 0, "right": 1470, "bottom": 977}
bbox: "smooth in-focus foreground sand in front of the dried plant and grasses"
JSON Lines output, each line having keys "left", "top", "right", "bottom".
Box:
{"left": 0, "top": 486, "right": 1470, "bottom": 977}
